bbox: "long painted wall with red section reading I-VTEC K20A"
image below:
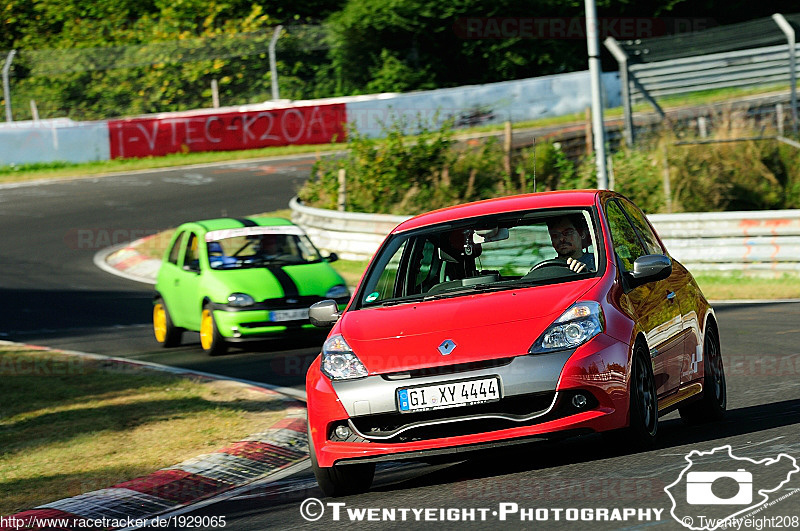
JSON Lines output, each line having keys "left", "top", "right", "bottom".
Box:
{"left": 0, "top": 71, "right": 621, "bottom": 165}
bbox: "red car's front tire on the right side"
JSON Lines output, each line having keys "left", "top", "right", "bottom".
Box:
{"left": 627, "top": 343, "right": 658, "bottom": 448}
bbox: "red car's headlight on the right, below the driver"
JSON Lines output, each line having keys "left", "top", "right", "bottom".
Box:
{"left": 528, "top": 301, "right": 605, "bottom": 354}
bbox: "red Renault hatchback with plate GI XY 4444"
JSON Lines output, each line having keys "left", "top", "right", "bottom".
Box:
{"left": 306, "top": 190, "right": 726, "bottom": 496}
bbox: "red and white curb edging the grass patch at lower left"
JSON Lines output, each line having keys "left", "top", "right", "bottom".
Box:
{"left": 0, "top": 341, "right": 308, "bottom": 530}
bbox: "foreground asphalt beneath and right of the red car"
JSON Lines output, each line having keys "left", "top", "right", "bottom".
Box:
{"left": 169, "top": 303, "right": 800, "bottom": 530}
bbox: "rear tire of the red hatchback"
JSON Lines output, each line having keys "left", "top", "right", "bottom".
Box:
{"left": 678, "top": 325, "right": 728, "bottom": 424}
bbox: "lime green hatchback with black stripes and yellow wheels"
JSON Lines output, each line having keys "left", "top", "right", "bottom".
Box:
{"left": 153, "top": 217, "right": 350, "bottom": 355}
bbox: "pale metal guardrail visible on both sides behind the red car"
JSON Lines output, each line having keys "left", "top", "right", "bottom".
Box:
{"left": 289, "top": 198, "right": 800, "bottom": 275}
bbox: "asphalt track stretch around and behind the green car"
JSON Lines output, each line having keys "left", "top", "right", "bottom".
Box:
{"left": 0, "top": 156, "right": 328, "bottom": 387}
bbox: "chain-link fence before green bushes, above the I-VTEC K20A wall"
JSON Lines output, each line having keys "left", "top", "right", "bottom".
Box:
{"left": 0, "top": 25, "right": 329, "bottom": 121}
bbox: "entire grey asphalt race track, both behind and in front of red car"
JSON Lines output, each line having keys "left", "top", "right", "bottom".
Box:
{"left": 0, "top": 157, "right": 800, "bottom": 531}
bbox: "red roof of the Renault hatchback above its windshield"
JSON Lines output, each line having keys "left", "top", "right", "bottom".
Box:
{"left": 392, "top": 190, "right": 599, "bottom": 233}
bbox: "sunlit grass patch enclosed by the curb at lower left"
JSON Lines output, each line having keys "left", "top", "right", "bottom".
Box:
{"left": 0, "top": 345, "right": 283, "bottom": 515}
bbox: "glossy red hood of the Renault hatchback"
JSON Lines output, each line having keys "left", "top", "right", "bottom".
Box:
{"left": 339, "top": 278, "right": 599, "bottom": 374}
